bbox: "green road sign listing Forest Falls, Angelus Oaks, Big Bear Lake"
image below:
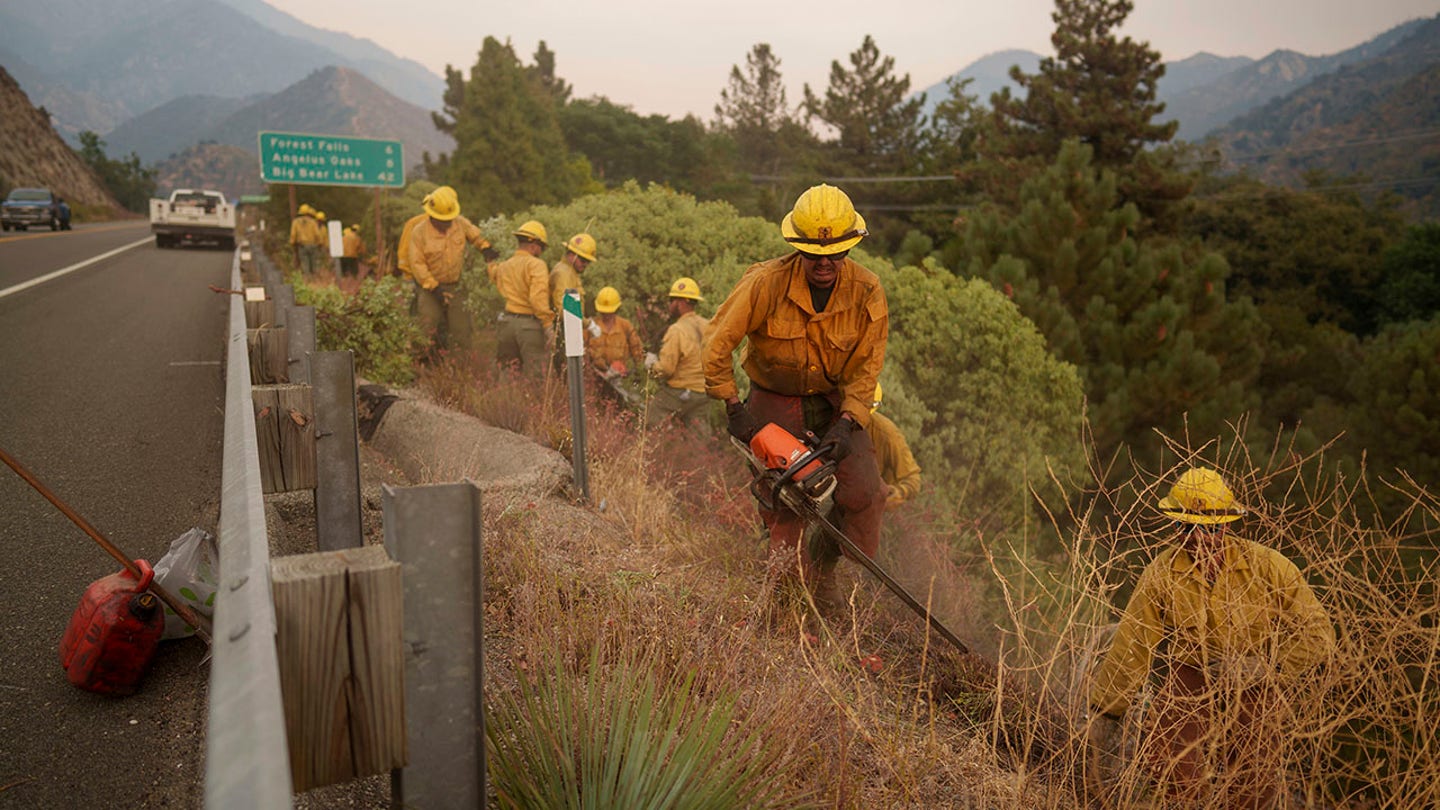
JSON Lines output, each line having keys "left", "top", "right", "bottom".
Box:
{"left": 259, "top": 133, "right": 405, "bottom": 187}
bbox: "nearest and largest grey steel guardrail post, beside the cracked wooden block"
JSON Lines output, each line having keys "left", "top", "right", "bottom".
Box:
{"left": 380, "top": 481, "right": 485, "bottom": 810}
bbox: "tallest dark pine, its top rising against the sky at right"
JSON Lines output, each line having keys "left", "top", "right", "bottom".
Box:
{"left": 982, "top": 0, "right": 1194, "bottom": 231}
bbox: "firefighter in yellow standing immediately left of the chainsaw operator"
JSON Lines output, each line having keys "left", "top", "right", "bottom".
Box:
{"left": 645, "top": 278, "right": 710, "bottom": 428}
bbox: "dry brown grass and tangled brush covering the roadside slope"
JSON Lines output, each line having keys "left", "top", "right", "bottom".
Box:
{"left": 420, "top": 360, "right": 1440, "bottom": 807}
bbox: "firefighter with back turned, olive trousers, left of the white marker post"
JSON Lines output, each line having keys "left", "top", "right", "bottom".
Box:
{"left": 490, "top": 219, "right": 554, "bottom": 379}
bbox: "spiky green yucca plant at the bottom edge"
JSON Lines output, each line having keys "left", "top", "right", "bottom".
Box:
{"left": 485, "top": 649, "right": 804, "bottom": 810}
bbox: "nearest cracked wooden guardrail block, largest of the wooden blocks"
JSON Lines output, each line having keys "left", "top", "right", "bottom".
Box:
{"left": 271, "top": 546, "right": 408, "bottom": 791}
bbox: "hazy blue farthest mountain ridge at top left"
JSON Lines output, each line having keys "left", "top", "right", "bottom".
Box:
{"left": 0, "top": 0, "right": 444, "bottom": 138}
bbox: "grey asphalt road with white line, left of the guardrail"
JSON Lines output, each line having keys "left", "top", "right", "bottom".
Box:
{"left": 0, "top": 222, "right": 230, "bottom": 809}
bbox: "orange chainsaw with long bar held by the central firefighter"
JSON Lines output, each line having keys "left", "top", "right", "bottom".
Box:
{"left": 734, "top": 422, "right": 971, "bottom": 654}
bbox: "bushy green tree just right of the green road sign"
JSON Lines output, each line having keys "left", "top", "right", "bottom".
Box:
{"left": 425, "top": 36, "right": 598, "bottom": 218}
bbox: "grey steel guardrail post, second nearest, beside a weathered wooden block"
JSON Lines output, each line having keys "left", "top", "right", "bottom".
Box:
{"left": 308, "top": 348, "right": 364, "bottom": 551}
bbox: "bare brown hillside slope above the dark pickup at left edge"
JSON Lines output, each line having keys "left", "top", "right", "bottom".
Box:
{"left": 0, "top": 68, "right": 120, "bottom": 212}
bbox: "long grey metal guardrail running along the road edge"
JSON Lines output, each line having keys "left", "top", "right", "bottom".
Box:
{"left": 204, "top": 248, "right": 294, "bottom": 810}
